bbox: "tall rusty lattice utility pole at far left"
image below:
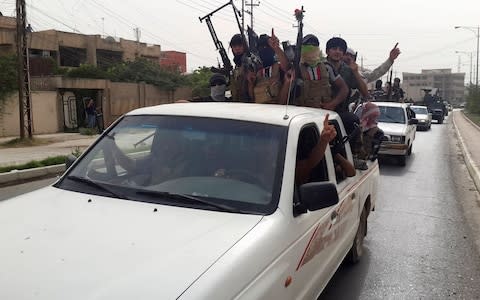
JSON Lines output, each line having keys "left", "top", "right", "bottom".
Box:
{"left": 16, "top": 0, "right": 32, "bottom": 139}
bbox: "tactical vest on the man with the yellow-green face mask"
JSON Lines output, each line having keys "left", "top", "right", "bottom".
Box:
{"left": 297, "top": 63, "right": 333, "bottom": 108}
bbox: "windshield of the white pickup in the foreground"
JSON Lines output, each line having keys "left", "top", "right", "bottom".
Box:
{"left": 56, "top": 115, "right": 287, "bottom": 214}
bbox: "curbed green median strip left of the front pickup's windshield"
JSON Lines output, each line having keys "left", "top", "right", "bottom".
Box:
{"left": 0, "top": 164, "right": 65, "bottom": 186}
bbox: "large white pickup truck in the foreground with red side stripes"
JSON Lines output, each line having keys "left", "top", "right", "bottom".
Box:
{"left": 0, "top": 103, "right": 379, "bottom": 300}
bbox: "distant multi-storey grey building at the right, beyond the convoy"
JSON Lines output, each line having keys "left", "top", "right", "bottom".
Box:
{"left": 402, "top": 69, "right": 465, "bottom": 103}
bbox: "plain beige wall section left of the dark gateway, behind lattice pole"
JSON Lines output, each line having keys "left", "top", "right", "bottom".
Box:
{"left": 0, "top": 92, "right": 63, "bottom": 136}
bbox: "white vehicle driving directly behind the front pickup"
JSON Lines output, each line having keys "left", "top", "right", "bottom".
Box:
{"left": 360, "top": 102, "right": 418, "bottom": 166}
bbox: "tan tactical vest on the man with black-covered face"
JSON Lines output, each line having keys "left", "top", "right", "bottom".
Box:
{"left": 253, "top": 64, "right": 280, "bottom": 103}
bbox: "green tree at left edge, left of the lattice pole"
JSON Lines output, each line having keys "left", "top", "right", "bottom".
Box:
{"left": 0, "top": 55, "right": 18, "bottom": 112}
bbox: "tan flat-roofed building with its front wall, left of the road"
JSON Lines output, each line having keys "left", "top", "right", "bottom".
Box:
{"left": 0, "top": 16, "right": 192, "bottom": 136}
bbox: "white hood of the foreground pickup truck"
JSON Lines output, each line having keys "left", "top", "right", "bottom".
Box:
{"left": 0, "top": 187, "right": 262, "bottom": 300}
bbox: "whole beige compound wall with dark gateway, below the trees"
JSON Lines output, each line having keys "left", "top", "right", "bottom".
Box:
{"left": 0, "top": 76, "right": 192, "bottom": 136}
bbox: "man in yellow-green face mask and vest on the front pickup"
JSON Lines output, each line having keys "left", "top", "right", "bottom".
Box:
{"left": 282, "top": 34, "right": 348, "bottom": 110}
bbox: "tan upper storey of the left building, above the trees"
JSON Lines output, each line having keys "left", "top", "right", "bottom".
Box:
{"left": 0, "top": 16, "right": 187, "bottom": 75}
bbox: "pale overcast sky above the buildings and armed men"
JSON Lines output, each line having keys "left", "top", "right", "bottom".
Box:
{"left": 0, "top": 0, "right": 480, "bottom": 80}
